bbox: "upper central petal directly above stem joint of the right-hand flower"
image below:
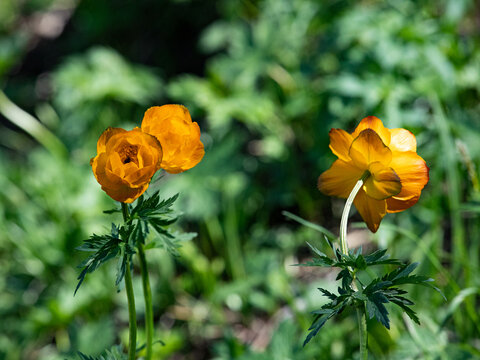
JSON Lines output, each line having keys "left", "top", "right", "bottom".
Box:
{"left": 349, "top": 129, "right": 392, "bottom": 170}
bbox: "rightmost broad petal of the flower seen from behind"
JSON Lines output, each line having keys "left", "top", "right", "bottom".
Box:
{"left": 390, "top": 151, "right": 429, "bottom": 199}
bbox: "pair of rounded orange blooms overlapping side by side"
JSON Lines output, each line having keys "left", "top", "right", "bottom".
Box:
{"left": 90, "top": 105, "right": 205, "bottom": 203}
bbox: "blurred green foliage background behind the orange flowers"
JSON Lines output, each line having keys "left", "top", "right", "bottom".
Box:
{"left": 0, "top": 0, "right": 480, "bottom": 360}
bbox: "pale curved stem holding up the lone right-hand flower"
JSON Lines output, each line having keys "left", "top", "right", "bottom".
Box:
{"left": 340, "top": 178, "right": 370, "bottom": 360}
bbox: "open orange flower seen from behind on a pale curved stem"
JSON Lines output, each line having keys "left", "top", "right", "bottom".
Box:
{"left": 318, "top": 116, "right": 429, "bottom": 232}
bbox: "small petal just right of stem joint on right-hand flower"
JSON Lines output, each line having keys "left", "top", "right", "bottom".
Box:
{"left": 363, "top": 162, "right": 402, "bottom": 200}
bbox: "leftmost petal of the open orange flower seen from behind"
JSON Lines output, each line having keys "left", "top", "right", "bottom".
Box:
{"left": 318, "top": 159, "right": 364, "bottom": 198}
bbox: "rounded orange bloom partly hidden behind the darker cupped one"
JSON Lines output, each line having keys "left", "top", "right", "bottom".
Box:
{"left": 142, "top": 105, "right": 205, "bottom": 174}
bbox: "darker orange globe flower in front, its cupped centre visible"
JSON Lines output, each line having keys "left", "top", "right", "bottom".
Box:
{"left": 90, "top": 127, "right": 162, "bottom": 203}
